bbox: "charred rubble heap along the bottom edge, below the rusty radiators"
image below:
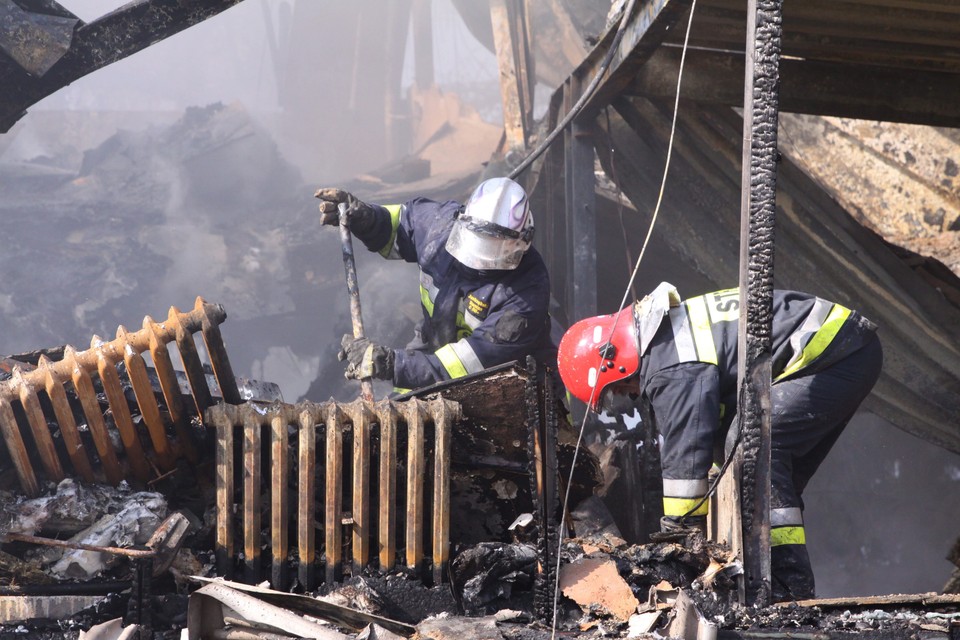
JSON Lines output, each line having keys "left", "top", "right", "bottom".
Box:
{"left": 0, "top": 470, "right": 960, "bottom": 640}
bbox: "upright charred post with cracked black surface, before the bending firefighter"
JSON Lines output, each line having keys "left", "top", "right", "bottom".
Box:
{"left": 736, "top": 0, "right": 783, "bottom": 606}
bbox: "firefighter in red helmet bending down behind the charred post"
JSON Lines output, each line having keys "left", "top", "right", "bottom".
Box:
{"left": 558, "top": 283, "right": 883, "bottom": 602}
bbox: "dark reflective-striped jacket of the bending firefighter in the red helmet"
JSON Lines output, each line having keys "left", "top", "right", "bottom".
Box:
{"left": 640, "top": 289, "right": 876, "bottom": 515}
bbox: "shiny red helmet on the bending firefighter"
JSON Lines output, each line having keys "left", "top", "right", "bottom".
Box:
{"left": 557, "top": 305, "right": 640, "bottom": 410}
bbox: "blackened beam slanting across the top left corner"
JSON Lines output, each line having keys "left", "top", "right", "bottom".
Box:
{"left": 0, "top": 0, "right": 251, "bottom": 133}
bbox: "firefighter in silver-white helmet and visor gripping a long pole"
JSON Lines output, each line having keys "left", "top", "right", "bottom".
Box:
{"left": 316, "top": 178, "right": 556, "bottom": 391}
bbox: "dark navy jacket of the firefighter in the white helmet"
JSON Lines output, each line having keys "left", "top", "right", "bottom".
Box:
{"left": 356, "top": 198, "right": 556, "bottom": 390}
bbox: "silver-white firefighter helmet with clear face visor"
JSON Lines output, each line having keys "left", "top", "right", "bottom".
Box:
{"left": 447, "top": 178, "right": 533, "bottom": 271}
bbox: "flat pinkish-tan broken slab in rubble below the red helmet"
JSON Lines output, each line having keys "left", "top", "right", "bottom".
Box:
{"left": 560, "top": 558, "right": 640, "bottom": 621}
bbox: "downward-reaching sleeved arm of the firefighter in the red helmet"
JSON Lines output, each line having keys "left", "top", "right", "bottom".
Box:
{"left": 644, "top": 362, "right": 720, "bottom": 517}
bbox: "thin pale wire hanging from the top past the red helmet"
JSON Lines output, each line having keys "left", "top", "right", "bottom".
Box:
{"left": 552, "top": 0, "right": 700, "bottom": 640}
